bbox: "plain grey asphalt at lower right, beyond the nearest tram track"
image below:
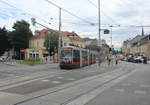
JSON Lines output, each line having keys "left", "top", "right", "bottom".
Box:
{"left": 85, "top": 64, "right": 150, "bottom": 105}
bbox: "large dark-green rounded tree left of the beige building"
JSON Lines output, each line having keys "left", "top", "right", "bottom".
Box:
{"left": 9, "top": 20, "right": 32, "bottom": 58}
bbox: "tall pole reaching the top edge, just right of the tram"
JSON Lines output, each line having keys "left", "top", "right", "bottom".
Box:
{"left": 98, "top": 0, "right": 101, "bottom": 66}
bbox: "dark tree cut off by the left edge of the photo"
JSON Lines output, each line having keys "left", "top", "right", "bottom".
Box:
{"left": 0, "top": 27, "right": 10, "bottom": 56}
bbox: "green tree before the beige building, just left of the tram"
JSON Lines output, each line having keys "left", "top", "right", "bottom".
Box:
{"left": 44, "top": 32, "right": 58, "bottom": 56}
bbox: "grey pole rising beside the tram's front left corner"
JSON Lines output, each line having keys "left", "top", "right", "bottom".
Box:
{"left": 58, "top": 8, "right": 61, "bottom": 63}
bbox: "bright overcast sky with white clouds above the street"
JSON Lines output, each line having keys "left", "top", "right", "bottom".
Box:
{"left": 0, "top": 0, "right": 150, "bottom": 48}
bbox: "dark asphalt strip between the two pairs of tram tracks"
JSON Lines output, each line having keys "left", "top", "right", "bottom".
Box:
{"left": 2, "top": 61, "right": 121, "bottom": 95}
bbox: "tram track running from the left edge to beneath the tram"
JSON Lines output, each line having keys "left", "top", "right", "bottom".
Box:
{"left": 0, "top": 63, "right": 99, "bottom": 91}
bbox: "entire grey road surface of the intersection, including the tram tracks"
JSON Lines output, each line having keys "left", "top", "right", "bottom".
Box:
{"left": 0, "top": 62, "right": 150, "bottom": 105}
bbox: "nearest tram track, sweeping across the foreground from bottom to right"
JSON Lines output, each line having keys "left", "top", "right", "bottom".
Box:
{"left": 12, "top": 63, "right": 135, "bottom": 105}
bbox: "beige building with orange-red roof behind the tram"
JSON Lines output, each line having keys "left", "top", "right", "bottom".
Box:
{"left": 25, "top": 29, "right": 85, "bottom": 59}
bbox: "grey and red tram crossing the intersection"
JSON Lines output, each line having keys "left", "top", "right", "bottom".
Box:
{"left": 60, "top": 46, "right": 98, "bottom": 69}
